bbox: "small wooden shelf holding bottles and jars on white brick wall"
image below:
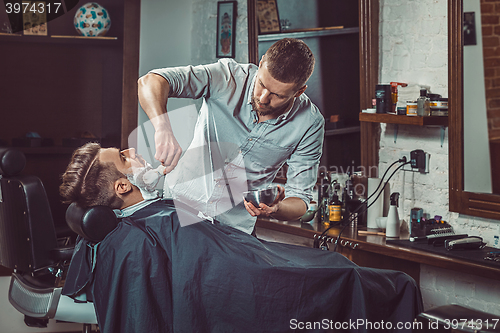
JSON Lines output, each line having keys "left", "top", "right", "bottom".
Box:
{"left": 359, "top": 112, "right": 448, "bottom": 126}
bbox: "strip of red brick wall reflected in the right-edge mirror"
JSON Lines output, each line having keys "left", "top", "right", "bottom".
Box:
{"left": 481, "top": 0, "right": 500, "bottom": 140}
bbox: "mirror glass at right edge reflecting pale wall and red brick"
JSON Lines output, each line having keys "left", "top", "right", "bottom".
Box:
{"left": 463, "top": 0, "right": 500, "bottom": 194}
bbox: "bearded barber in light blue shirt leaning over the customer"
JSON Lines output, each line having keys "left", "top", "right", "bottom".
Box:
{"left": 139, "top": 38, "right": 324, "bottom": 233}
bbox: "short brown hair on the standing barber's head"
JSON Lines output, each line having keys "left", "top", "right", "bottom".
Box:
{"left": 263, "top": 38, "right": 315, "bottom": 88}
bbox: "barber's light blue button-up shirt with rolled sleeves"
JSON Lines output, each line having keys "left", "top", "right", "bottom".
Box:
{"left": 151, "top": 59, "right": 324, "bottom": 233}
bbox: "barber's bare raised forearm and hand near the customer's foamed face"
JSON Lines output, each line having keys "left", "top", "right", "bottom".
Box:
{"left": 138, "top": 73, "right": 182, "bottom": 173}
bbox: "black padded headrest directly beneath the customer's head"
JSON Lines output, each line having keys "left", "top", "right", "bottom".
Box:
{"left": 66, "top": 203, "right": 118, "bottom": 243}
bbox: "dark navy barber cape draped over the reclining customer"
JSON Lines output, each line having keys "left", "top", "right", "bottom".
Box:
{"left": 63, "top": 201, "right": 422, "bottom": 333}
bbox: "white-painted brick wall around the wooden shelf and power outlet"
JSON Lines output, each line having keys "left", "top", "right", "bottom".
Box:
{"left": 379, "top": 0, "right": 500, "bottom": 314}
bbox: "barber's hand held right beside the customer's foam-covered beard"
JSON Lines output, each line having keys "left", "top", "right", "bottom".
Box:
{"left": 155, "top": 129, "right": 182, "bottom": 174}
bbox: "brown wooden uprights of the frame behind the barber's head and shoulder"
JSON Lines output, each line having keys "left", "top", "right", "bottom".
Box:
{"left": 247, "top": 0, "right": 380, "bottom": 177}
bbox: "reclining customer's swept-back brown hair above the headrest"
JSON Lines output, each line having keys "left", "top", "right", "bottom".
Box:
{"left": 59, "top": 143, "right": 126, "bottom": 208}
